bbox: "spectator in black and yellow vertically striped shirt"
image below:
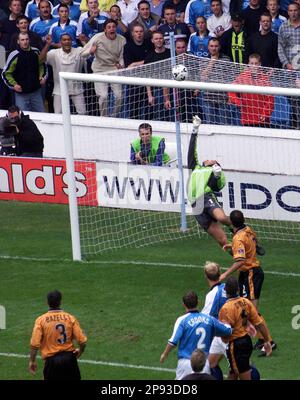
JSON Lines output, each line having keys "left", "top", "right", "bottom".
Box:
{"left": 221, "top": 14, "right": 249, "bottom": 64}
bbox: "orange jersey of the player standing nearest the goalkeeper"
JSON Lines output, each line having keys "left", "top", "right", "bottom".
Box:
{"left": 232, "top": 226, "right": 260, "bottom": 271}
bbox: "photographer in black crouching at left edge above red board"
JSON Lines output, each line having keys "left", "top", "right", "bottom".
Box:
{"left": 0, "top": 106, "right": 44, "bottom": 157}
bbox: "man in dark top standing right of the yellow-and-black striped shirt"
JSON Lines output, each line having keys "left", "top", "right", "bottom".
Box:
{"left": 249, "top": 13, "right": 281, "bottom": 68}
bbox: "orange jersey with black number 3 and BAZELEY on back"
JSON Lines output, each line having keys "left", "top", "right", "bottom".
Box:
{"left": 30, "top": 310, "right": 87, "bottom": 359}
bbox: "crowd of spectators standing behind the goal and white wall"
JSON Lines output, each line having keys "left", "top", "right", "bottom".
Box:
{"left": 0, "top": 0, "right": 300, "bottom": 129}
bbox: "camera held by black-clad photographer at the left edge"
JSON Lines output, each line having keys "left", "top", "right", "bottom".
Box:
{"left": 0, "top": 117, "right": 18, "bottom": 156}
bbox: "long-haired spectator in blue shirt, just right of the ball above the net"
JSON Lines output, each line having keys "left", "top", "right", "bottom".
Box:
{"left": 187, "top": 17, "right": 210, "bottom": 57}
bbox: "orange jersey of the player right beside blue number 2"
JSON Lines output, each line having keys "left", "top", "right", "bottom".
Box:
{"left": 219, "top": 297, "right": 263, "bottom": 341}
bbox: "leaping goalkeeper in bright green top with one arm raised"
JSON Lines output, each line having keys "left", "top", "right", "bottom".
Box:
{"left": 188, "top": 116, "right": 231, "bottom": 248}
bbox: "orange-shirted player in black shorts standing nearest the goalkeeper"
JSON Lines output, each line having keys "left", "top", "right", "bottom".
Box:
{"left": 220, "top": 210, "right": 277, "bottom": 356}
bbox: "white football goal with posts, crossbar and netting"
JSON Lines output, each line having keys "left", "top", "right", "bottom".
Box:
{"left": 60, "top": 55, "right": 300, "bottom": 260}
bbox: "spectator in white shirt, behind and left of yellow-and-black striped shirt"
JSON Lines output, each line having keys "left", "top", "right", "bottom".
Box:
{"left": 207, "top": 0, "right": 231, "bottom": 38}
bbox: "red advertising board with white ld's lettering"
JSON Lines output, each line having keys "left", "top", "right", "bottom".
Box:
{"left": 0, "top": 157, "right": 98, "bottom": 206}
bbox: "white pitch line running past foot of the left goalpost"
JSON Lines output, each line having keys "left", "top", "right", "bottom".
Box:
{"left": 0, "top": 255, "right": 300, "bottom": 278}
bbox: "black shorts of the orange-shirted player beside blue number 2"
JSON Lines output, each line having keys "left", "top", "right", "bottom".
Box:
{"left": 226, "top": 335, "right": 253, "bottom": 374}
